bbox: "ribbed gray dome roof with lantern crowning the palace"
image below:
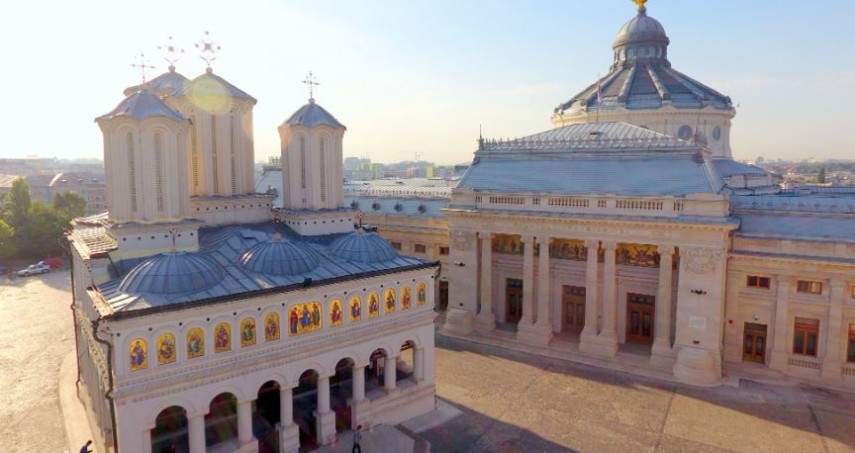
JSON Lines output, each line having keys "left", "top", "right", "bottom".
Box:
{"left": 555, "top": 7, "right": 733, "bottom": 114}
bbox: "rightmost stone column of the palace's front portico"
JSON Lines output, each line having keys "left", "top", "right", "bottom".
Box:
{"left": 650, "top": 245, "right": 676, "bottom": 364}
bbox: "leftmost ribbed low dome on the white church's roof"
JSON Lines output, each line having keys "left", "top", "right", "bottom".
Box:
{"left": 119, "top": 252, "right": 225, "bottom": 294}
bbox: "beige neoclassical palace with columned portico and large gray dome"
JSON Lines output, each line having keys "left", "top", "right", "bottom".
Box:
{"left": 345, "top": 1, "right": 855, "bottom": 390}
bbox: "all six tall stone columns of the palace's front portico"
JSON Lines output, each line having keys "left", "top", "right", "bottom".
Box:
{"left": 475, "top": 232, "right": 675, "bottom": 360}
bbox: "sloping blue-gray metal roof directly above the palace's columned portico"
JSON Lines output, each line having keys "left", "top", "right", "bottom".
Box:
{"left": 459, "top": 122, "right": 723, "bottom": 196}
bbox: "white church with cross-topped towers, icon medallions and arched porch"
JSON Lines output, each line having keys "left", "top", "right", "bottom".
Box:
{"left": 68, "top": 57, "right": 438, "bottom": 452}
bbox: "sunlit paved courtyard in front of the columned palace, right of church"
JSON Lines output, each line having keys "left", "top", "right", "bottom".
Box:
{"left": 422, "top": 335, "right": 855, "bottom": 453}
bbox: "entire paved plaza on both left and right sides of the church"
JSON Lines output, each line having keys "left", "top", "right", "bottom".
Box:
{"left": 0, "top": 272, "right": 855, "bottom": 453}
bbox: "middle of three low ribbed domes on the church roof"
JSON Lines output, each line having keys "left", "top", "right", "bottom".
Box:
{"left": 238, "top": 239, "right": 318, "bottom": 275}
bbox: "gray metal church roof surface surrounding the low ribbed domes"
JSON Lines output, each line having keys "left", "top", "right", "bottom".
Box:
{"left": 98, "top": 223, "right": 432, "bottom": 314}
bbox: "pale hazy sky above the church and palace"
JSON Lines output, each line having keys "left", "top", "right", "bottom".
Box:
{"left": 0, "top": 0, "right": 855, "bottom": 164}
